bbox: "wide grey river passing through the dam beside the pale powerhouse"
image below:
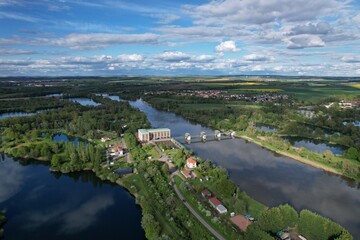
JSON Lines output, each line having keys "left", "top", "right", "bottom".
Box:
{"left": 130, "top": 100, "right": 360, "bottom": 239}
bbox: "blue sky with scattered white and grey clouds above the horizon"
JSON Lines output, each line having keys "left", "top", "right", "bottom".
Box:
{"left": 0, "top": 0, "right": 360, "bottom": 76}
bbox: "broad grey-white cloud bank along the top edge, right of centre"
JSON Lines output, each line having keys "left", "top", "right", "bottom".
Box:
{"left": 185, "top": 0, "right": 345, "bottom": 25}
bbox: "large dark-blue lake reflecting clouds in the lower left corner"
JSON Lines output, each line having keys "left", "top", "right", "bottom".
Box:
{"left": 0, "top": 155, "right": 145, "bottom": 240}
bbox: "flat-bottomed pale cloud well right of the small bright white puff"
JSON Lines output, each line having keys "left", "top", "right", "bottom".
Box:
{"left": 285, "top": 34, "right": 325, "bottom": 49}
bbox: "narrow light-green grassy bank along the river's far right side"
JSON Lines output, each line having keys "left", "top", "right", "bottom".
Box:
{"left": 236, "top": 135, "right": 342, "bottom": 176}
